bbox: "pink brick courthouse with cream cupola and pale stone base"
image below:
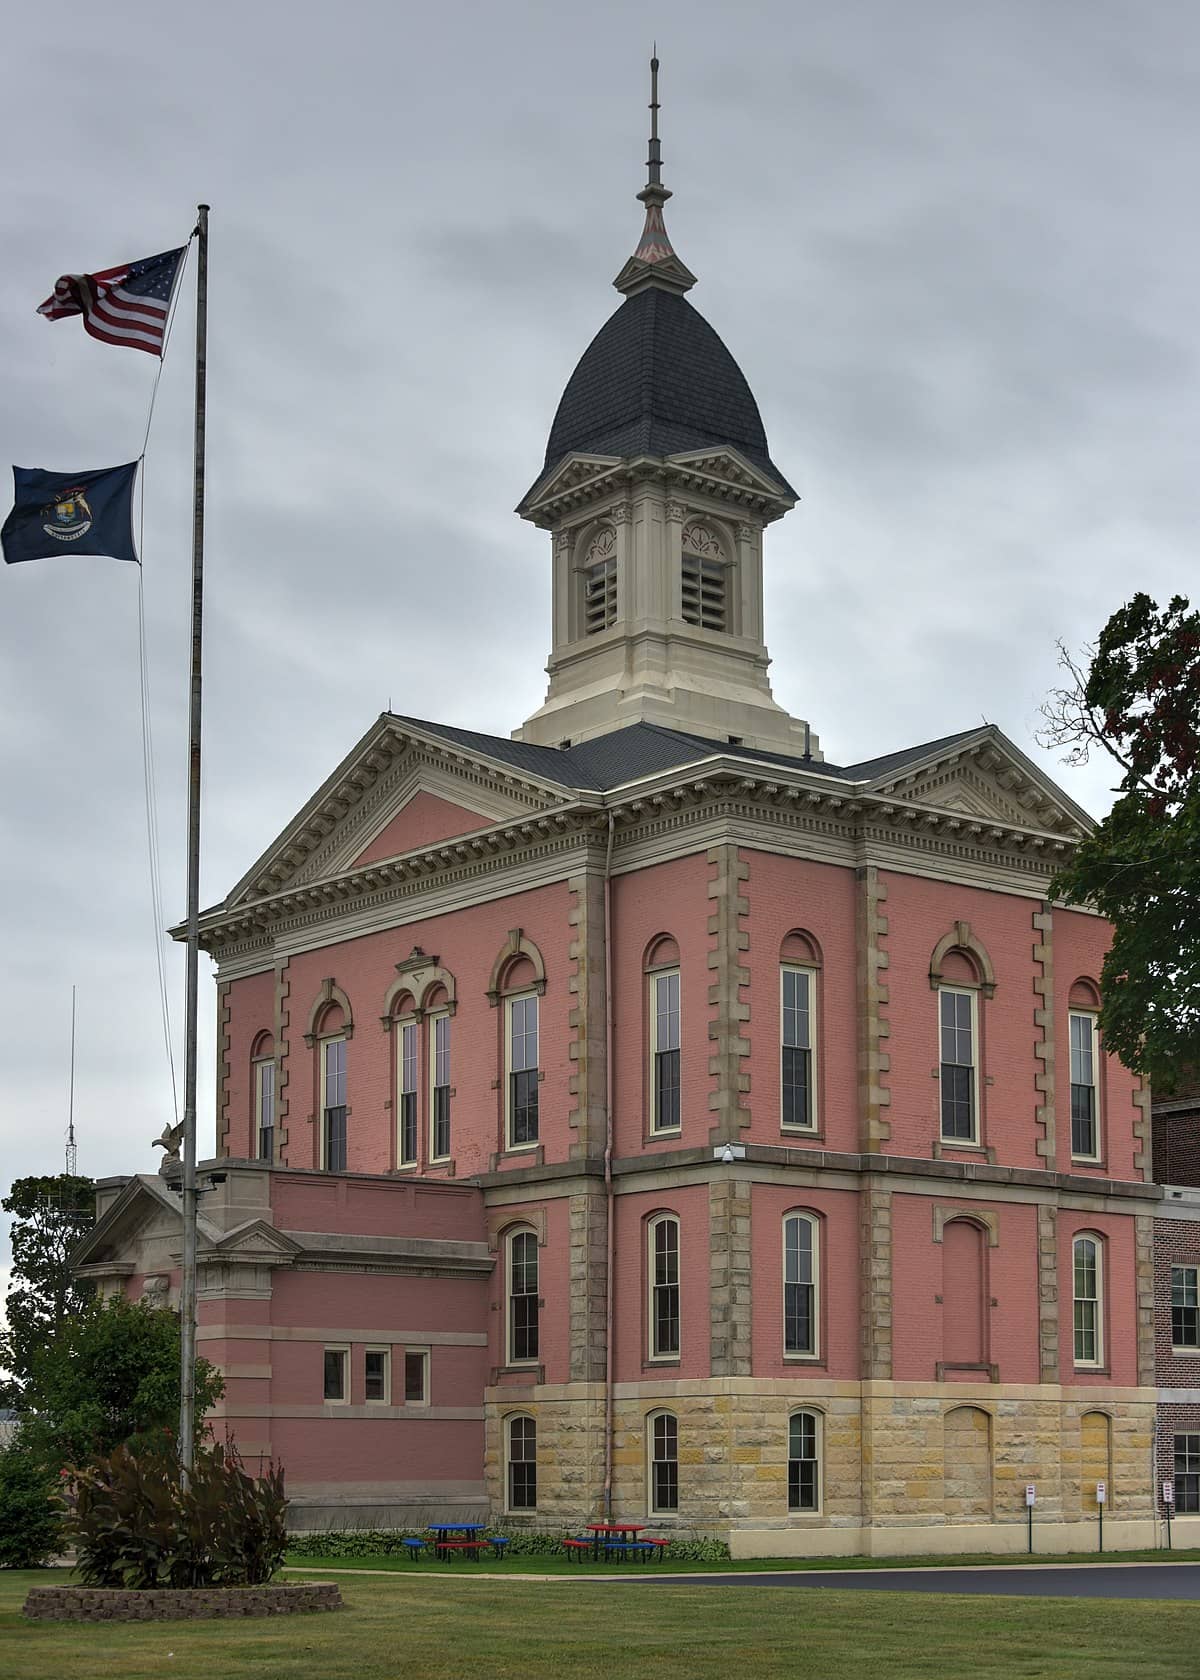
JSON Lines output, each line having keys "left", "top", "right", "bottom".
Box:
{"left": 81, "top": 88, "right": 1200, "bottom": 1556}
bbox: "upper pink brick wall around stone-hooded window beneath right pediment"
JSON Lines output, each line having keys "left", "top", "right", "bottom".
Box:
{"left": 882, "top": 874, "right": 1044, "bottom": 1168}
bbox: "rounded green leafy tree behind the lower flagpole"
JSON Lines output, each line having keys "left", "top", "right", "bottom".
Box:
{"left": 20, "top": 1295, "right": 225, "bottom": 1470}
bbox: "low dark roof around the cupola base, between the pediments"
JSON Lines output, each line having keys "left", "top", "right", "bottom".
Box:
{"left": 395, "top": 717, "right": 978, "bottom": 793}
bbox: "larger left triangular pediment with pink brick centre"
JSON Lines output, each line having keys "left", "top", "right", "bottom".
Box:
{"left": 224, "top": 716, "right": 565, "bottom": 909}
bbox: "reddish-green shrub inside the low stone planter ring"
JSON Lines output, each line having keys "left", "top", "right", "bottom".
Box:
{"left": 64, "top": 1445, "right": 287, "bottom": 1588}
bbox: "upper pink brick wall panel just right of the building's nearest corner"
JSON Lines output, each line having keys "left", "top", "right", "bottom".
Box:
{"left": 741, "top": 850, "right": 859, "bottom": 1151}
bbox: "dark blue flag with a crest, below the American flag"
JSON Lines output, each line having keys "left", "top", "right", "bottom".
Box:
{"left": 0, "top": 460, "right": 138, "bottom": 566}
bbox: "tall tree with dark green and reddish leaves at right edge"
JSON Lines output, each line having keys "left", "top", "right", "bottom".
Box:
{"left": 1042, "top": 595, "right": 1200, "bottom": 1092}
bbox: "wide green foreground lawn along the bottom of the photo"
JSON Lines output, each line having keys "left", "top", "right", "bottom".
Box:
{"left": 0, "top": 1571, "right": 1197, "bottom": 1680}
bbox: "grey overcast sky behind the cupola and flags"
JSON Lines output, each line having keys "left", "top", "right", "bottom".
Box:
{"left": 0, "top": 0, "right": 1200, "bottom": 1270}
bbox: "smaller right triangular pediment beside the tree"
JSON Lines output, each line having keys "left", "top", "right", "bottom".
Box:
{"left": 869, "top": 724, "right": 1091, "bottom": 838}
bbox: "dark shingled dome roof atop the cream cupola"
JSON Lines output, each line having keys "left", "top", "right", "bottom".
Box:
{"left": 543, "top": 286, "right": 795, "bottom": 496}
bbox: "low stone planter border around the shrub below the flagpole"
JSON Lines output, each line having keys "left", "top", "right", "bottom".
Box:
{"left": 25, "top": 1581, "right": 341, "bottom": 1621}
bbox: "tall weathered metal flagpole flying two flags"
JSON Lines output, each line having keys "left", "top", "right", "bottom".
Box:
{"left": 180, "top": 205, "right": 208, "bottom": 1487}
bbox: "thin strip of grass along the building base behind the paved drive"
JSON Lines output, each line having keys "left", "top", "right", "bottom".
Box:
{"left": 286, "top": 1549, "right": 1200, "bottom": 1576}
